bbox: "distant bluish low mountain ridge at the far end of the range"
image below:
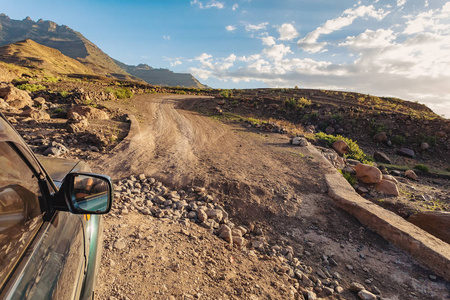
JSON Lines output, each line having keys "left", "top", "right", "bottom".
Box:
{"left": 115, "top": 60, "right": 206, "bottom": 88}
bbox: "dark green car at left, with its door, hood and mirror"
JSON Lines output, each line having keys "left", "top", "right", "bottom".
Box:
{"left": 0, "top": 113, "right": 113, "bottom": 299}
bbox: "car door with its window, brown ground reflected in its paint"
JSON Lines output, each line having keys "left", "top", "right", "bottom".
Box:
{"left": 0, "top": 118, "right": 86, "bottom": 299}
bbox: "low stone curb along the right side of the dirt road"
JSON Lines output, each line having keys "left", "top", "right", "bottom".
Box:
{"left": 325, "top": 172, "right": 450, "bottom": 282}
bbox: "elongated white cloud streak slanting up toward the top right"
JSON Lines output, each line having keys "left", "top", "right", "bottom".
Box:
{"left": 297, "top": 5, "right": 388, "bottom": 53}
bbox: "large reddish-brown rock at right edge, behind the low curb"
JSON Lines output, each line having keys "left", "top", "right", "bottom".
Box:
{"left": 408, "top": 211, "right": 450, "bottom": 244}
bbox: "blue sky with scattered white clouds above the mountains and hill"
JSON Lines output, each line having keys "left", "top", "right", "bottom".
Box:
{"left": 0, "top": 0, "right": 450, "bottom": 118}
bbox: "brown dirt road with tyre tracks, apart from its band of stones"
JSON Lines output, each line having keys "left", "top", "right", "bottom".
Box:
{"left": 91, "top": 95, "right": 449, "bottom": 299}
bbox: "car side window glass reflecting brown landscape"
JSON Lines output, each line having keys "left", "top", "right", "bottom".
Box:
{"left": 0, "top": 141, "right": 42, "bottom": 285}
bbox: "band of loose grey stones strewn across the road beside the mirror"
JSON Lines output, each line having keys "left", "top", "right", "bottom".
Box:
{"left": 110, "top": 174, "right": 386, "bottom": 299}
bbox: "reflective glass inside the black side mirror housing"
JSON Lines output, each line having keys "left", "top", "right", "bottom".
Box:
{"left": 73, "top": 174, "right": 111, "bottom": 213}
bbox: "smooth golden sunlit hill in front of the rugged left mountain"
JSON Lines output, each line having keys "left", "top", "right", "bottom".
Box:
{"left": 0, "top": 40, "right": 95, "bottom": 75}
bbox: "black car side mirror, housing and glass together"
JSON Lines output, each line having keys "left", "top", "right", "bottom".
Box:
{"left": 55, "top": 173, "right": 113, "bottom": 214}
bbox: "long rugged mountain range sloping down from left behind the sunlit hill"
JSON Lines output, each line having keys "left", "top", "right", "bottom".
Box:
{"left": 0, "top": 14, "right": 205, "bottom": 88}
